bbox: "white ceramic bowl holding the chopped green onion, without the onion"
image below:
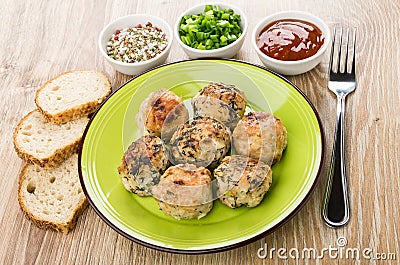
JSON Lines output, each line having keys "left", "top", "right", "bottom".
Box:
{"left": 174, "top": 2, "right": 248, "bottom": 59}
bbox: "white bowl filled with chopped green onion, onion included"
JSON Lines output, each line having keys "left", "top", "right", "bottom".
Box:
{"left": 174, "top": 3, "right": 248, "bottom": 59}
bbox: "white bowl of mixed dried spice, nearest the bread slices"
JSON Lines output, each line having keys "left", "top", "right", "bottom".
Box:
{"left": 98, "top": 14, "right": 173, "bottom": 75}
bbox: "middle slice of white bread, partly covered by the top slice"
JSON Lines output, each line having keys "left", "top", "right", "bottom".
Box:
{"left": 14, "top": 110, "right": 89, "bottom": 167}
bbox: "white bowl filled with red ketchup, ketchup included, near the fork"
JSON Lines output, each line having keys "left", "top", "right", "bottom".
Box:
{"left": 251, "top": 11, "right": 331, "bottom": 75}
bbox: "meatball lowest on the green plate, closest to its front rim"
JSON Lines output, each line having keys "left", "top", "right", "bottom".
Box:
{"left": 153, "top": 164, "right": 213, "bottom": 220}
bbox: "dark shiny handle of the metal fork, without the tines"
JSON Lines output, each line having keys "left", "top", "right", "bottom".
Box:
{"left": 322, "top": 94, "right": 350, "bottom": 227}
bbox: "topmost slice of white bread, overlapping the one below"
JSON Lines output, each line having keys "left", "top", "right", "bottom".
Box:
{"left": 35, "top": 70, "right": 111, "bottom": 124}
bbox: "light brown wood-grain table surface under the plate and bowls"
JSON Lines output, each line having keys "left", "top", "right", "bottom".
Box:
{"left": 0, "top": 0, "right": 400, "bottom": 265}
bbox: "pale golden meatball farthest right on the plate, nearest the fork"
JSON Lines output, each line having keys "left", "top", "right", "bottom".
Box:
{"left": 232, "top": 112, "right": 287, "bottom": 165}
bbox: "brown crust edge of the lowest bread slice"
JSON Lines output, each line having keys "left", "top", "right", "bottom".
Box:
{"left": 18, "top": 161, "right": 89, "bottom": 234}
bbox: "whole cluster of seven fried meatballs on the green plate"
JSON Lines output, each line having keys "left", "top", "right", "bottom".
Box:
{"left": 118, "top": 82, "right": 287, "bottom": 219}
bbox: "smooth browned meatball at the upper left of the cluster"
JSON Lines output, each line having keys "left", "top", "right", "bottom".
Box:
{"left": 136, "top": 89, "right": 189, "bottom": 140}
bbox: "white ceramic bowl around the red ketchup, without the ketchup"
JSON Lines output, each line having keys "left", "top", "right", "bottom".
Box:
{"left": 251, "top": 11, "right": 331, "bottom": 75}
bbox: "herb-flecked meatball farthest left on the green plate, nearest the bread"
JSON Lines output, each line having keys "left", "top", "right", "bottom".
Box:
{"left": 118, "top": 135, "right": 169, "bottom": 196}
